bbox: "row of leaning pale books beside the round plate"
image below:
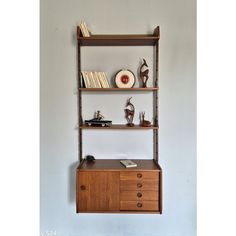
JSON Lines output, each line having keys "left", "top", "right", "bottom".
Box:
{"left": 81, "top": 71, "right": 110, "bottom": 88}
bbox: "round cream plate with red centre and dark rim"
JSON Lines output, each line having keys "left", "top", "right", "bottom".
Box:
{"left": 115, "top": 70, "right": 135, "bottom": 88}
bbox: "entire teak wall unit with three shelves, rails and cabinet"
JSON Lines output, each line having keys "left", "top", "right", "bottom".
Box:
{"left": 76, "top": 27, "right": 162, "bottom": 214}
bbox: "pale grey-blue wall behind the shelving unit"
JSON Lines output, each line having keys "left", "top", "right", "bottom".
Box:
{"left": 40, "top": 0, "right": 196, "bottom": 236}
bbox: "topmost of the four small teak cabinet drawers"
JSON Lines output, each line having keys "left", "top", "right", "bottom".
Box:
{"left": 120, "top": 171, "right": 158, "bottom": 180}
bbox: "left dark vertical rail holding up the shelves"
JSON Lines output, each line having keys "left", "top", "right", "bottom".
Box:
{"left": 77, "top": 39, "right": 83, "bottom": 162}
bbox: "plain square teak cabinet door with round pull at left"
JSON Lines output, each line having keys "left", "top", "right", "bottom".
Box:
{"left": 77, "top": 171, "right": 119, "bottom": 211}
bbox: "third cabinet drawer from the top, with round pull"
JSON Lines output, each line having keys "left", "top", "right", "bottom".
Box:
{"left": 120, "top": 191, "right": 158, "bottom": 201}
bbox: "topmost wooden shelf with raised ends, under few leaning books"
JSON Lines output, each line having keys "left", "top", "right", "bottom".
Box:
{"left": 77, "top": 26, "right": 160, "bottom": 46}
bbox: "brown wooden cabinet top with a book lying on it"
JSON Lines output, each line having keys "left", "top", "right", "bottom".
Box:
{"left": 77, "top": 159, "right": 161, "bottom": 172}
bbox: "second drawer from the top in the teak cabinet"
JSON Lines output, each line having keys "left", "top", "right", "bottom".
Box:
{"left": 120, "top": 180, "right": 158, "bottom": 191}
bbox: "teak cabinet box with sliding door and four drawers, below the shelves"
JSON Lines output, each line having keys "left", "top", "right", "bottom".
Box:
{"left": 76, "top": 160, "right": 162, "bottom": 214}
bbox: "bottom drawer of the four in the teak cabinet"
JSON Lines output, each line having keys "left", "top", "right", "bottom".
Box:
{"left": 120, "top": 201, "right": 159, "bottom": 211}
